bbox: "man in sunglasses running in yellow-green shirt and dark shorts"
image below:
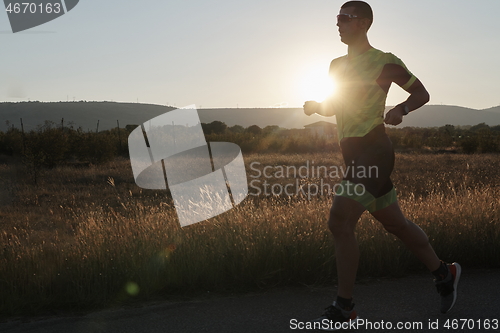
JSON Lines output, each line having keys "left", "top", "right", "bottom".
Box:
{"left": 304, "top": 1, "right": 461, "bottom": 322}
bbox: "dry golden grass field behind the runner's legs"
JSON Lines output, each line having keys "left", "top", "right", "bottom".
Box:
{"left": 0, "top": 154, "right": 500, "bottom": 315}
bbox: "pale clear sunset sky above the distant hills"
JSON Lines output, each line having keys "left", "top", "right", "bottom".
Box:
{"left": 0, "top": 0, "right": 500, "bottom": 109}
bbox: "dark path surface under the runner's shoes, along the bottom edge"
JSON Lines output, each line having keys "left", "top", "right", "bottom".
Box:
{"left": 0, "top": 269, "right": 500, "bottom": 333}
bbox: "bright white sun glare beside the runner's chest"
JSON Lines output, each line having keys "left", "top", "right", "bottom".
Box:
{"left": 300, "top": 65, "right": 335, "bottom": 102}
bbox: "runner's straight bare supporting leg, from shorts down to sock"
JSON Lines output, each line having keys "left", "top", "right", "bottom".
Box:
{"left": 328, "top": 196, "right": 365, "bottom": 299}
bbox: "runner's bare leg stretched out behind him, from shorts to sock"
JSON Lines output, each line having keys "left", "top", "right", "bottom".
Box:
{"left": 371, "top": 198, "right": 441, "bottom": 272}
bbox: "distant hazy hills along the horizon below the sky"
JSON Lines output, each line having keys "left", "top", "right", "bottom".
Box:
{"left": 0, "top": 102, "right": 500, "bottom": 131}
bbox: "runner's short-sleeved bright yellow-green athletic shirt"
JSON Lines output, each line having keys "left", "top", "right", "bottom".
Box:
{"left": 321, "top": 48, "right": 417, "bottom": 142}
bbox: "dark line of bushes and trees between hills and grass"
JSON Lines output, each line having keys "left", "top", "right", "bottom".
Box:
{"left": 0, "top": 121, "right": 500, "bottom": 169}
